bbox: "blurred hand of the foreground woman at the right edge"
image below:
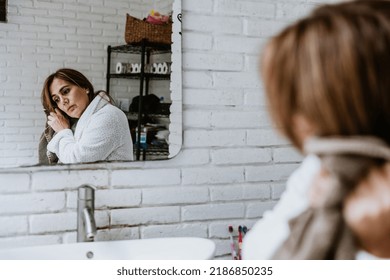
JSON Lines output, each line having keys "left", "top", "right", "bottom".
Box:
{"left": 343, "top": 163, "right": 390, "bottom": 258}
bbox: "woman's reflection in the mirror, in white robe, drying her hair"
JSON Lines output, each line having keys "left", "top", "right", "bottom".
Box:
{"left": 39, "top": 68, "right": 133, "bottom": 164}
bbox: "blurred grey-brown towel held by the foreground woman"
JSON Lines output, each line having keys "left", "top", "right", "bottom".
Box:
{"left": 273, "top": 136, "right": 390, "bottom": 260}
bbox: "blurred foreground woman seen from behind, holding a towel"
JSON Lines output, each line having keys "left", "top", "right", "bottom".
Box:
{"left": 243, "top": 1, "right": 390, "bottom": 259}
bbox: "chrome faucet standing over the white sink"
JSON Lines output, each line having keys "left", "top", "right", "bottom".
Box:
{"left": 77, "top": 185, "right": 96, "bottom": 242}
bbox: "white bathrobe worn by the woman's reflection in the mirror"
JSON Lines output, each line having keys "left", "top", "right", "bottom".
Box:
{"left": 47, "top": 93, "right": 133, "bottom": 163}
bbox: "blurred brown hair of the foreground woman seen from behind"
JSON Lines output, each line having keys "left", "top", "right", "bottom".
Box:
{"left": 261, "top": 1, "right": 390, "bottom": 148}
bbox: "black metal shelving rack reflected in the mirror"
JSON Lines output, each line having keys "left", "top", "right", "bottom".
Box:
{"left": 106, "top": 39, "right": 171, "bottom": 160}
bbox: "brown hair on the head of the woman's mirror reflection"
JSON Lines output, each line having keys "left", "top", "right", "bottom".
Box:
{"left": 41, "top": 68, "right": 96, "bottom": 113}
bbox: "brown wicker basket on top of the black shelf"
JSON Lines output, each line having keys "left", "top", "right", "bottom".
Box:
{"left": 125, "top": 14, "right": 172, "bottom": 44}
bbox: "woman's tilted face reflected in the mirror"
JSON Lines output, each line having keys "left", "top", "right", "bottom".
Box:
{"left": 49, "top": 78, "right": 89, "bottom": 119}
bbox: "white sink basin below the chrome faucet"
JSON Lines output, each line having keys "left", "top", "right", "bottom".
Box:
{"left": 0, "top": 237, "right": 215, "bottom": 260}
